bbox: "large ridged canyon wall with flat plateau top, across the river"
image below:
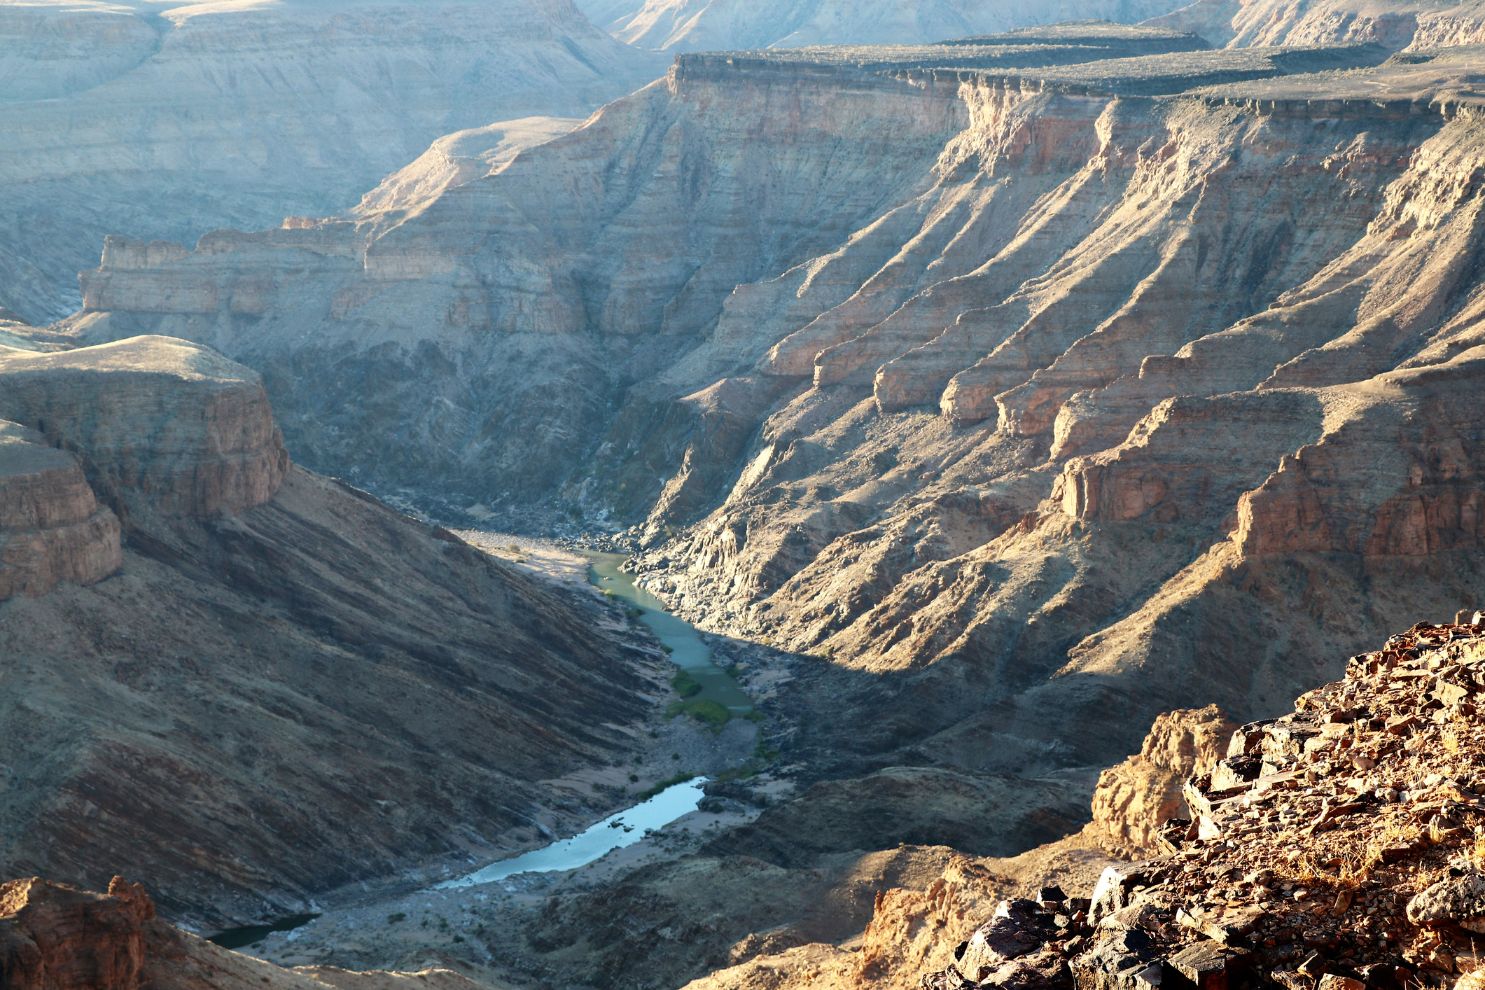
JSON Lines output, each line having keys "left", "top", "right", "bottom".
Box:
{"left": 68, "top": 25, "right": 1485, "bottom": 770}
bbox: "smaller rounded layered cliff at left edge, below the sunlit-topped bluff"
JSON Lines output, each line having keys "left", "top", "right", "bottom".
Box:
{"left": 0, "top": 422, "right": 123, "bottom": 601}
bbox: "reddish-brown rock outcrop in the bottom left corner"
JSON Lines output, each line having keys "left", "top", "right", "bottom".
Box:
{"left": 0, "top": 877, "right": 493, "bottom": 990}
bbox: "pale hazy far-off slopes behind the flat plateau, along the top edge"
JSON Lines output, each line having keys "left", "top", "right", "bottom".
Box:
{"left": 578, "top": 0, "right": 1184, "bottom": 52}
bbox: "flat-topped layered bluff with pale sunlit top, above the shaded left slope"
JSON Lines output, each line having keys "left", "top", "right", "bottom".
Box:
{"left": 0, "top": 337, "right": 288, "bottom": 517}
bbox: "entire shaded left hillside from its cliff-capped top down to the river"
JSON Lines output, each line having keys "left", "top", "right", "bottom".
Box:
{"left": 0, "top": 330, "right": 661, "bottom": 932}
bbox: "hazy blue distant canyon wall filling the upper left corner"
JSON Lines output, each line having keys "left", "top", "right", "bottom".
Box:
{"left": 0, "top": 0, "right": 664, "bottom": 322}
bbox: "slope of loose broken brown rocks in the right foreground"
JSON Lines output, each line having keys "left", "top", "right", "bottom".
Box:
{"left": 922, "top": 623, "right": 1485, "bottom": 990}
